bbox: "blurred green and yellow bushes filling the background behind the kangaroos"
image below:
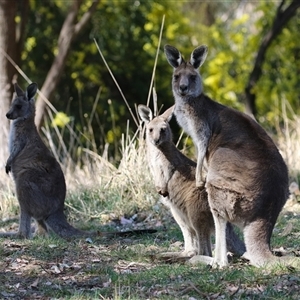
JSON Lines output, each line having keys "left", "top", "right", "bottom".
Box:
{"left": 0, "top": 0, "right": 300, "bottom": 162}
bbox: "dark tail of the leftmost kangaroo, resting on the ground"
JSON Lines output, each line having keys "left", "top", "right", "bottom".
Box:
{"left": 45, "top": 212, "right": 94, "bottom": 239}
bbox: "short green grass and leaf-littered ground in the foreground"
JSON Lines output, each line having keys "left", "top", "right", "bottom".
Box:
{"left": 0, "top": 197, "right": 300, "bottom": 299}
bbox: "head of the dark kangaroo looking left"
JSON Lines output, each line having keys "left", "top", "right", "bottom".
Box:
{"left": 6, "top": 83, "right": 37, "bottom": 120}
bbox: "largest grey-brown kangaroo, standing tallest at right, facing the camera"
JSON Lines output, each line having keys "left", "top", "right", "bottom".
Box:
{"left": 165, "top": 45, "right": 288, "bottom": 266}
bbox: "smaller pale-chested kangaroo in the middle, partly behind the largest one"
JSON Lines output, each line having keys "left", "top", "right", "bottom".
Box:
{"left": 138, "top": 105, "right": 245, "bottom": 257}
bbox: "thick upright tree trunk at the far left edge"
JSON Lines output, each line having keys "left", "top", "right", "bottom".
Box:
{"left": 0, "top": 0, "right": 17, "bottom": 166}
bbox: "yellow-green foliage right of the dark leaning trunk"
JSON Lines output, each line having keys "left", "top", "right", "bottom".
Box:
{"left": 255, "top": 5, "right": 300, "bottom": 124}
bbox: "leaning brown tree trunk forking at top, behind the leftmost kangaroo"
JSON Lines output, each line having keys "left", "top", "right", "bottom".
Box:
{"left": 35, "top": 0, "right": 100, "bottom": 130}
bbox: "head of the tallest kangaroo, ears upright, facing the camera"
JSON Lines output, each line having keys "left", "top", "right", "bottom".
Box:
{"left": 165, "top": 45, "right": 208, "bottom": 98}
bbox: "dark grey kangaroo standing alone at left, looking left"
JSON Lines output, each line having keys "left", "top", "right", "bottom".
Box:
{"left": 1, "top": 83, "right": 90, "bottom": 238}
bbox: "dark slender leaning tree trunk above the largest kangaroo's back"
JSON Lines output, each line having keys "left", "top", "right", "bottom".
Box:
{"left": 245, "top": 0, "right": 300, "bottom": 117}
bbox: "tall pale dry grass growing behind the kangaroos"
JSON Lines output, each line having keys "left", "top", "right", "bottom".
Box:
{"left": 0, "top": 97, "right": 300, "bottom": 219}
